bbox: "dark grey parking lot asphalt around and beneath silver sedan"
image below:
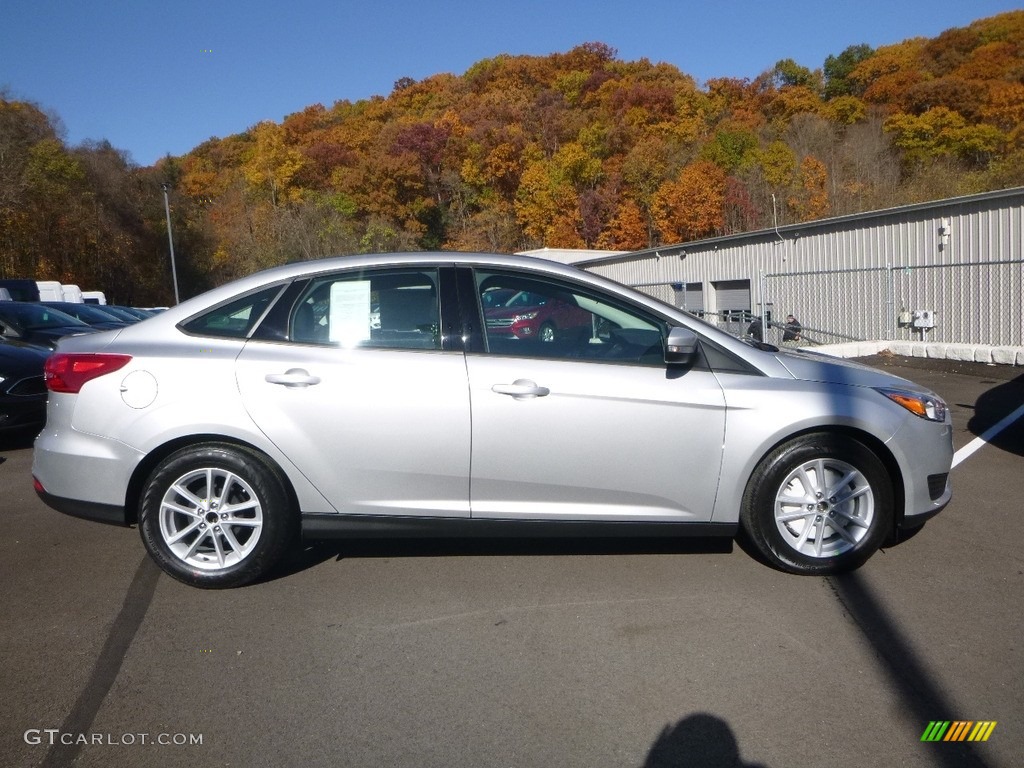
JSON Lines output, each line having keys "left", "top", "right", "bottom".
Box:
{"left": 0, "top": 355, "right": 1024, "bottom": 768}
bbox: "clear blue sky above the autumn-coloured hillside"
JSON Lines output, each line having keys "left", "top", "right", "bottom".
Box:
{"left": 0, "top": 0, "right": 1020, "bottom": 165}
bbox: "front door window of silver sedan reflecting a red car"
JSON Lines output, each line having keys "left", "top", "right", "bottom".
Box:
{"left": 476, "top": 271, "right": 665, "bottom": 365}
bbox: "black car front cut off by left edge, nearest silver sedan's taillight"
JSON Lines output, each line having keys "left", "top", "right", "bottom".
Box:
{"left": 0, "top": 339, "right": 50, "bottom": 434}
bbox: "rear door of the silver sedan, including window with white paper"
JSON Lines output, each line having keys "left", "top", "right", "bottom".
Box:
{"left": 237, "top": 268, "right": 470, "bottom": 517}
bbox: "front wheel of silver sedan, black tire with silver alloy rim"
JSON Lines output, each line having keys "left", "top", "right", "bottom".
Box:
{"left": 740, "top": 434, "right": 895, "bottom": 575}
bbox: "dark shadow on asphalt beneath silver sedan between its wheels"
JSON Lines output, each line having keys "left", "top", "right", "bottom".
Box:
{"left": 262, "top": 537, "right": 734, "bottom": 581}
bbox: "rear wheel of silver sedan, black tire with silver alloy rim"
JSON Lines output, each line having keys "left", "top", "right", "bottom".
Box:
{"left": 138, "top": 443, "right": 298, "bottom": 589}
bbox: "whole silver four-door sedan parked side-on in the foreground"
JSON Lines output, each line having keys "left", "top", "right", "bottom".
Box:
{"left": 33, "top": 253, "right": 952, "bottom": 588}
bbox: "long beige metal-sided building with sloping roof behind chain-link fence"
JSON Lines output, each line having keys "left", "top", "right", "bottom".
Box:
{"left": 574, "top": 187, "right": 1024, "bottom": 346}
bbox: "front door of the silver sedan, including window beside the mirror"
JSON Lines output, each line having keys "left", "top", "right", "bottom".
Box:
{"left": 466, "top": 269, "right": 725, "bottom": 521}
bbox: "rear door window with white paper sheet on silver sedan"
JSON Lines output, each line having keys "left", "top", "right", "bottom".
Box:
{"left": 289, "top": 269, "right": 441, "bottom": 349}
